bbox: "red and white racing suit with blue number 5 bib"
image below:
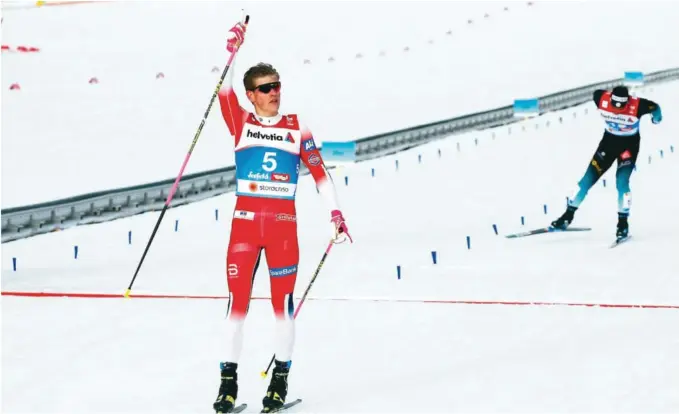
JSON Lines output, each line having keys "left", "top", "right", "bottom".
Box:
{"left": 219, "top": 64, "right": 339, "bottom": 362}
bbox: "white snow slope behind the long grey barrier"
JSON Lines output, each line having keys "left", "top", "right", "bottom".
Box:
{"left": 2, "top": 1, "right": 679, "bottom": 208}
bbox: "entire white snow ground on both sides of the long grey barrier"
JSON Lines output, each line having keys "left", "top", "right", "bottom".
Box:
{"left": 0, "top": 2, "right": 679, "bottom": 414}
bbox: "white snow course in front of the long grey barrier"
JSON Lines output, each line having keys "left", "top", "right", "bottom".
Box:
{"left": 2, "top": 77, "right": 679, "bottom": 413}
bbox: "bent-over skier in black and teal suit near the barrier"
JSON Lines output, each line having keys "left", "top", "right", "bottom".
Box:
{"left": 551, "top": 86, "right": 662, "bottom": 240}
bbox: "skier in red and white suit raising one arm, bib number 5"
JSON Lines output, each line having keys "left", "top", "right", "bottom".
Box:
{"left": 214, "top": 23, "right": 351, "bottom": 412}
